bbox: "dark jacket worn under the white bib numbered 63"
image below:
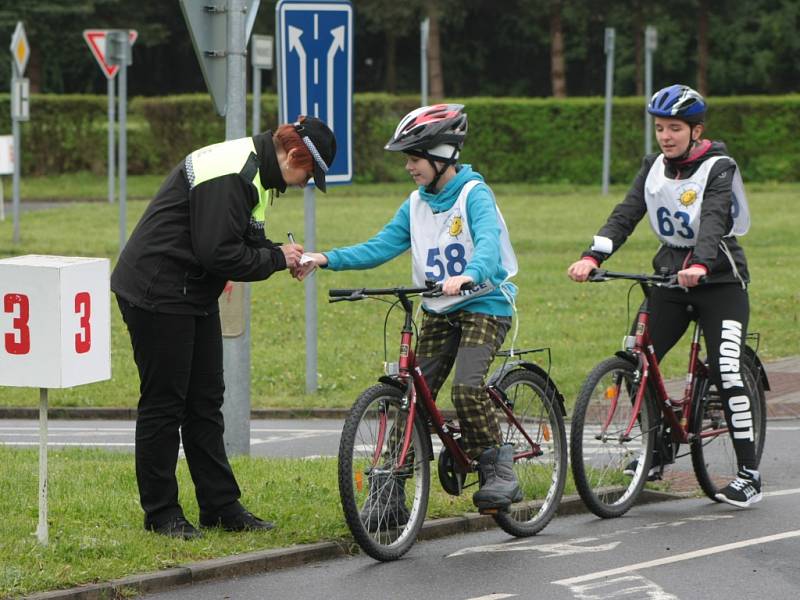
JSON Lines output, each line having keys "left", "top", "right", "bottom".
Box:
{"left": 582, "top": 142, "right": 749, "bottom": 283}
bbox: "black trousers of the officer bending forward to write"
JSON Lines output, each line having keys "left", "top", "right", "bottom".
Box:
{"left": 117, "top": 297, "right": 243, "bottom": 526}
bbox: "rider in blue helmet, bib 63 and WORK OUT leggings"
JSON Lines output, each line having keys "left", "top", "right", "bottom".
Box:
{"left": 567, "top": 85, "right": 761, "bottom": 507}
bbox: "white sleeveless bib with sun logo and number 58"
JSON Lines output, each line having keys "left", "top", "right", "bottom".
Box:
{"left": 409, "top": 179, "right": 518, "bottom": 312}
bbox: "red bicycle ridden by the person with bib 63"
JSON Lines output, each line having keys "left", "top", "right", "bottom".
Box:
{"left": 570, "top": 269, "right": 769, "bottom": 518}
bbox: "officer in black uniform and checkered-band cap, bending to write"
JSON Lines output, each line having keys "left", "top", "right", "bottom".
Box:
{"left": 111, "top": 117, "right": 336, "bottom": 539}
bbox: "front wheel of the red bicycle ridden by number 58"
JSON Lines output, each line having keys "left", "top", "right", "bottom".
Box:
{"left": 339, "top": 384, "right": 430, "bottom": 561}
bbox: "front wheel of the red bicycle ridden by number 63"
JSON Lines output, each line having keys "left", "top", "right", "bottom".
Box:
{"left": 570, "top": 357, "right": 656, "bottom": 518}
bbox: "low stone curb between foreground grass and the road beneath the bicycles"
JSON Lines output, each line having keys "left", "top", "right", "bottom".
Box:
{"left": 25, "top": 490, "right": 690, "bottom": 600}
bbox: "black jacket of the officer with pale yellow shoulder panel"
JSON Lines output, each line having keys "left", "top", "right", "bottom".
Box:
{"left": 111, "top": 131, "right": 286, "bottom": 315}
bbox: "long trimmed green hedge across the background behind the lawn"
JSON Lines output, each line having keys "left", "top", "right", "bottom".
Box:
{"left": 0, "top": 94, "right": 800, "bottom": 184}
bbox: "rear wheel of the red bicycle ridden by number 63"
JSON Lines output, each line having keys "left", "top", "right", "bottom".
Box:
{"left": 689, "top": 359, "right": 767, "bottom": 502}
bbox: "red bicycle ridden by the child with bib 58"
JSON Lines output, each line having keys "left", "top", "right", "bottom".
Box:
{"left": 329, "top": 284, "right": 567, "bottom": 561}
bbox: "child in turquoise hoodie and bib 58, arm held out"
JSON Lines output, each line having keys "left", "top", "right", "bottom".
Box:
{"left": 299, "top": 104, "right": 522, "bottom": 510}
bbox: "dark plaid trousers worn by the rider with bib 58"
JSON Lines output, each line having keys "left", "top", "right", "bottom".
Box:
{"left": 417, "top": 310, "right": 511, "bottom": 458}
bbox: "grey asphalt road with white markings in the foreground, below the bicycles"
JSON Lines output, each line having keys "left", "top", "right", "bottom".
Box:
{"left": 117, "top": 419, "right": 800, "bottom": 600}
